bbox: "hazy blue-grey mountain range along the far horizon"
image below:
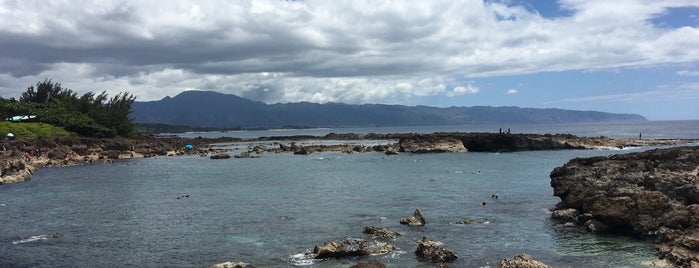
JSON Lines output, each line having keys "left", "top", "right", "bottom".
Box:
{"left": 131, "top": 91, "right": 647, "bottom": 128}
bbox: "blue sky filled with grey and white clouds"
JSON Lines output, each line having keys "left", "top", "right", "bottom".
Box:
{"left": 0, "top": 0, "right": 699, "bottom": 120}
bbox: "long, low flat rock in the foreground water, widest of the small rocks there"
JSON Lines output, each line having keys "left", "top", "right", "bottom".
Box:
{"left": 313, "top": 239, "right": 395, "bottom": 259}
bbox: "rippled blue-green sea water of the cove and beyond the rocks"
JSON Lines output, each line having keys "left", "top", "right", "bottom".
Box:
{"left": 0, "top": 121, "right": 699, "bottom": 267}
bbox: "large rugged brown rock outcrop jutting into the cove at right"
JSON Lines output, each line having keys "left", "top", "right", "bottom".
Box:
{"left": 551, "top": 147, "right": 699, "bottom": 267}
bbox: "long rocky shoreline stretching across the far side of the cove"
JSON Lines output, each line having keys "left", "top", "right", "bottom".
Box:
{"left": 0, "top": 132, "right": 699, "bottom": 185}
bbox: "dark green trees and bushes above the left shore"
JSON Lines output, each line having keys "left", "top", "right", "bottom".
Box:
{"left": 0, "top": 79, "right": 136, "bottom": 137}
